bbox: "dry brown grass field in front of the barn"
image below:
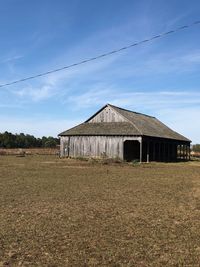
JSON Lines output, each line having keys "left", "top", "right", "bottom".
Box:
{"left": 0, "top": 155, "right": 200, "bottom": 267}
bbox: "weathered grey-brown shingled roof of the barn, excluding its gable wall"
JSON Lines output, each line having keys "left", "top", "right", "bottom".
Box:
{"left": 59, "top": 104, "right": 190, "bottom": 142}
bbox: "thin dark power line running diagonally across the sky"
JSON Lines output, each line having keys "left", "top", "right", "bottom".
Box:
{"left": 0, "top": 21, "right": 200, "bottom": 88}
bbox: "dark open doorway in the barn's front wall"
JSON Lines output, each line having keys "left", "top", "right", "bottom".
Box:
{"left": 124, "top": 140, "right": 140, "bottom": 161}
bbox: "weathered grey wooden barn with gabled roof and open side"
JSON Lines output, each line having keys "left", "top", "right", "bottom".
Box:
{"left": 59, "top": 104, "right": 191, "bottom": 162}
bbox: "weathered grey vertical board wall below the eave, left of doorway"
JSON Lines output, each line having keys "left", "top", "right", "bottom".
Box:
{"left": 60, "top": 136, "right": 141, "bottom": 159}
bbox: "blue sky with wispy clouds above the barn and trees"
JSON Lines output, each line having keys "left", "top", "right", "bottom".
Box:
{"left": 0, "top": 0, "right": 200, "bottom": 143}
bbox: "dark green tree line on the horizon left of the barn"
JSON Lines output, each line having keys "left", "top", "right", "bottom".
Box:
{"left": 0, "top": 131, "right": 59, "bottom": 148}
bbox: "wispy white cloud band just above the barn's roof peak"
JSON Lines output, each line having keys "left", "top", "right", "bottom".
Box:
{"left": 67, "top": 88, "right": 200, "bottom": 110}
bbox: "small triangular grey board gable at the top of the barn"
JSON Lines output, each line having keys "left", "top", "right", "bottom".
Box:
{"left": 88, "top": 106, "right": 126, "bottom": 123}
